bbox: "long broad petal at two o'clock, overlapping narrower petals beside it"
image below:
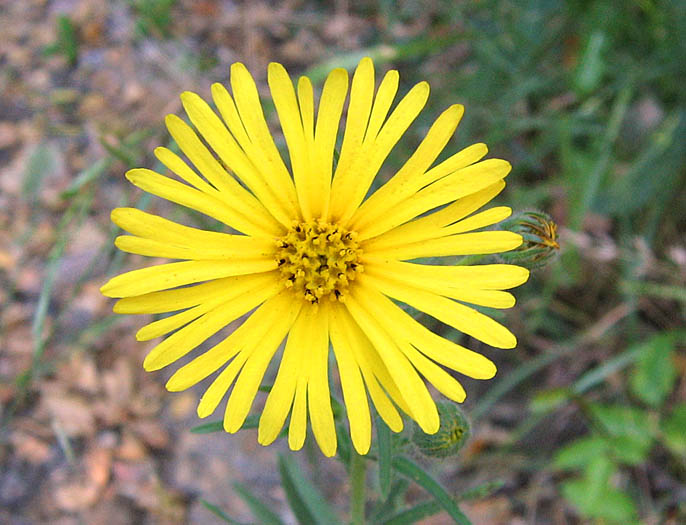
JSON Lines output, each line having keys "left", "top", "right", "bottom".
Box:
{"left": 356, "top": 159, "right": 512, "bottom": 240}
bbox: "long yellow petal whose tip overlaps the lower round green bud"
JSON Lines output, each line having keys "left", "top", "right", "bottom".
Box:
{"left": 345, "top": 293, "right": 439, "bottom": 434}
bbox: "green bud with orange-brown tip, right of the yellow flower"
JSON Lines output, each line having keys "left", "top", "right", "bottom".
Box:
{"left": 500, "top": 210, "right": 560, "bottom": 270}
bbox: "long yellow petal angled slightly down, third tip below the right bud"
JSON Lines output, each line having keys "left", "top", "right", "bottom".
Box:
{"left": 366, "top": 275, "right": 517, "bottom": 348}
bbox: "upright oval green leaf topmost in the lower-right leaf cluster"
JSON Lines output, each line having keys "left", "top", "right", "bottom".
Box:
{"left": 629, "top": 333, "right": 676, "bottom": 407}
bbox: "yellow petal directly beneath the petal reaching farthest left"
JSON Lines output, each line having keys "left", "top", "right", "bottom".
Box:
{"left": 113, "top": 272, "right": 279, "bottom": 314}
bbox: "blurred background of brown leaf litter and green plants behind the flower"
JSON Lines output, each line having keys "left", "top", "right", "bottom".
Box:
{"left": 0, "top": 0, "right": 686, "bottom": 524}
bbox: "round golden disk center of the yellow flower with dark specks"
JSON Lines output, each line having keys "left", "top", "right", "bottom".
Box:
{"left": 276, "top": 220, "right": 362, "bottom": 303}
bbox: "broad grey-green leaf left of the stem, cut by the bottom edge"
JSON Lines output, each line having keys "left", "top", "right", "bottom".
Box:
{"left": 278, "top": 454, "right": 339, "bottom": 525}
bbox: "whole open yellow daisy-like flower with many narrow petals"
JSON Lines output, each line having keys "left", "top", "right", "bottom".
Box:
{"left": 102, "top": 58, "right": 529, "bottom": 456}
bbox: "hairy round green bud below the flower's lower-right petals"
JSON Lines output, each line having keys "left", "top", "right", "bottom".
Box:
{"left": 412, "top": 401, "right": 470, "bottom": 458}
